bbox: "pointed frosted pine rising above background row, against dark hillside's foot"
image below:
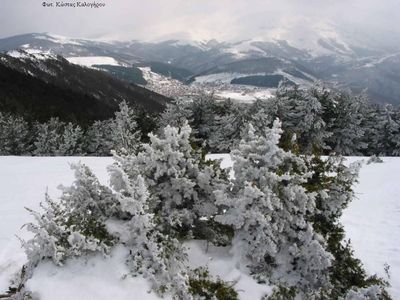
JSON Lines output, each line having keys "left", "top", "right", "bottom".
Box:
{"left": 111, "top": 101, "right": 140, "bottom": 153}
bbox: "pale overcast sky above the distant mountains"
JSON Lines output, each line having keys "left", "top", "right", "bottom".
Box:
{"left": 0, "top": 0, "right": 400, "bottom": 46}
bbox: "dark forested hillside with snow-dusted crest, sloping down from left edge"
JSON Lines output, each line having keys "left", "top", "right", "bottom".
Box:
{"left": 0, "top": 50, "right": 170, "bottom": 123}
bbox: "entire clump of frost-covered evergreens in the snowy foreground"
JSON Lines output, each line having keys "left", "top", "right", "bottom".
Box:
{"left": 12, "top": 121, "right": 390, "bottom": 300}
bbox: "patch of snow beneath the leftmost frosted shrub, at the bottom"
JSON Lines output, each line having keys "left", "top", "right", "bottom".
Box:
{"left": 27, "top": 246, "right": 164, "bottom": 300}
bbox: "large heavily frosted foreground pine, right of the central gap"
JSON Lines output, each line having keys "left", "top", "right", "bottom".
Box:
{"left": 215, "top": 121, "right": 332, "bottom": 290}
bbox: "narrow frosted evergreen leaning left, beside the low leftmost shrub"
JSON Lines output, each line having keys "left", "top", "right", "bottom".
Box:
{"left": 109, "top": 163, "right": 191, "bottom": 299}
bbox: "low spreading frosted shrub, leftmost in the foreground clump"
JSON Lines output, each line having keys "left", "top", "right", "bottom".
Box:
{"left": 23, "top": 164, "right": 117, "bottom": 265}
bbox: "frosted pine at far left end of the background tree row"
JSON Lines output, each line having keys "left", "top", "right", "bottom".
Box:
{"left": 0, "top": 112, "right": 31, "bottom": 155}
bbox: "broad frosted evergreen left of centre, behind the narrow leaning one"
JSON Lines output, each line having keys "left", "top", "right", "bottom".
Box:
{"left": 112, "top": 125, "right": 227, "bottom": 237}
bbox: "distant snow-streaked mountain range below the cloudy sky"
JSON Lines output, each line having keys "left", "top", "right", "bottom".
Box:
{"left": 0, "top": 30, "right": 400, "bottom": 104}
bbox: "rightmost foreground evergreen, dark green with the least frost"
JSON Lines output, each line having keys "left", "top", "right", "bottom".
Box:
{"left": 304, "top": 156, "right": 389, "bottom": 299}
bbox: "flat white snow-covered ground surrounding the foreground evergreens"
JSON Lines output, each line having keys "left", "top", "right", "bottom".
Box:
{"left": 0, "top": 155, "right": 400, "bottom": 300}
